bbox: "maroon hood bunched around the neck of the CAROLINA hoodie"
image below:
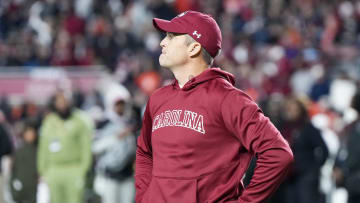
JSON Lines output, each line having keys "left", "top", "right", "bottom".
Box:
{"left": 173, "top": 67, "right": 235, "bottom": 91}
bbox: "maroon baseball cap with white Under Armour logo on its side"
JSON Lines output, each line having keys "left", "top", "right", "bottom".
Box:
{"left": 153, "top": 11, "right": 222, "bottom": 57}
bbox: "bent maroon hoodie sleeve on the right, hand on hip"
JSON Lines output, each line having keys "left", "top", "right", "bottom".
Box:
{"left": 221, "top": 90, "right": 293, "bottom": 203}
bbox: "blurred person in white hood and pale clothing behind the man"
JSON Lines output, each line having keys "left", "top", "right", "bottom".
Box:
{"left": 93, "top": 84, "right": 137, "bottom": 203}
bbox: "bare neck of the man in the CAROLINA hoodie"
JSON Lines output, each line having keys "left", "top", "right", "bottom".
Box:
{"left": 171, "top": 62, "right": 209, "bottom": 88}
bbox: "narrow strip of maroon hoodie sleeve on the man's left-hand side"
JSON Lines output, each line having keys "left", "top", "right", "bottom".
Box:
{"left": 135, "top": 102, "right": 153, "bottom": 202}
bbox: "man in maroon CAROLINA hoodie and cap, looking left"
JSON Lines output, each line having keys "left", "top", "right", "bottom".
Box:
{"left": 135, "top": 11, "right": 293, "bottom": 203}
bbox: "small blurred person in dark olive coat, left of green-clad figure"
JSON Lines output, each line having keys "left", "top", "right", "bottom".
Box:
{"left": 10, "top": 122, "right": 38, "bottom": 203}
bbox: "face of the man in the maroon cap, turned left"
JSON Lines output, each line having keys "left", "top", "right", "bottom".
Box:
{"left": 159, "top": 32, "right": 188, "bottom": 68}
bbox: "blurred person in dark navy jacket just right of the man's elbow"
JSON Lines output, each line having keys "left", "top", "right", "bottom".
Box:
{"left": 283, "top": 97, "right": 329, "bottom": 203}
